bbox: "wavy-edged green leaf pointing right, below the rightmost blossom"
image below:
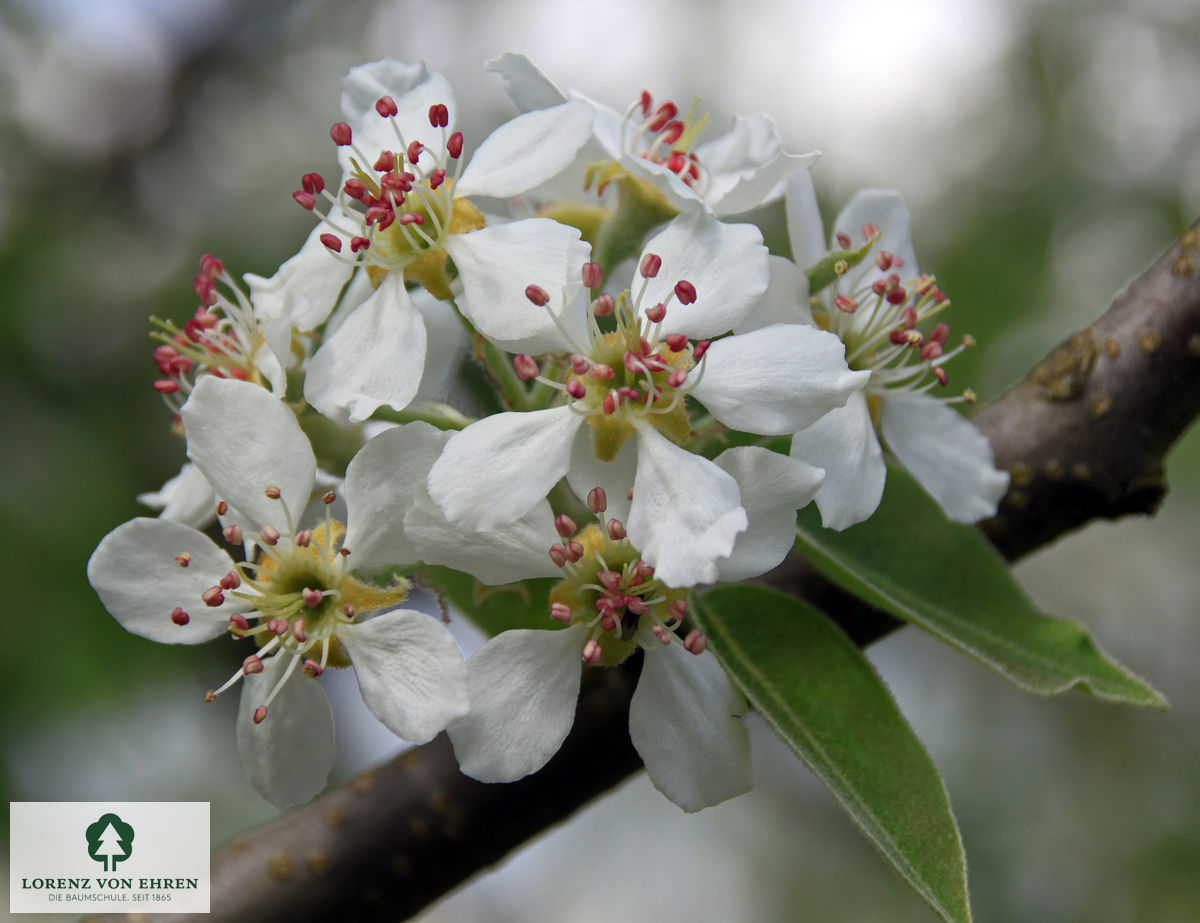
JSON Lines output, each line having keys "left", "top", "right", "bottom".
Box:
{"left": 797, "top": 468, "right": 1166, "bottom": 708}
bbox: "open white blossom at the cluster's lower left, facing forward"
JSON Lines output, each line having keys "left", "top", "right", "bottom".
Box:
{"left": 88, "top": 376, "right": 467, "bottom": 807}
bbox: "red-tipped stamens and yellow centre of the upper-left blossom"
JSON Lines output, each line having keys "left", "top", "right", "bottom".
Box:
{"left": 292, "top": 96, "right": 484, "bottom": 299}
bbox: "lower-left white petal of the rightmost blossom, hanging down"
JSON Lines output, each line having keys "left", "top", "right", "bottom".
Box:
{"left": 792, "top": 392, "right": 887, "bottom": 529}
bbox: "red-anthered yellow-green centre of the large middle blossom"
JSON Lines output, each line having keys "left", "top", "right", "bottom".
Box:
{"left": 514, "top": 259, "right": 708, "bottom": 461}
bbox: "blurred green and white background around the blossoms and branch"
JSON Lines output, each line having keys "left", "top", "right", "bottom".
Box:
{"left": 0, "top": 0, "right": 1200, "bottom": 923}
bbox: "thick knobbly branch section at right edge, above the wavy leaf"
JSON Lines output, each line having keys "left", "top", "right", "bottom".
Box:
{"left": 974, "top": 224, "right": 1200, "bottom": 558}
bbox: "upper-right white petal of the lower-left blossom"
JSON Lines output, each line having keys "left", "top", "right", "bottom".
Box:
{"left": 343, "top": 422, "right": 450, "bottom": 568}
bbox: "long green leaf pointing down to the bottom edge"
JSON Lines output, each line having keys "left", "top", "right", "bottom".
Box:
{"left": 694, "top": 586, "right": 971, "bottom": 923}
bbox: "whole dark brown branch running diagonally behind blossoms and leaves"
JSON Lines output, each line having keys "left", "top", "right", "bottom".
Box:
{"left": 93, "top": 220, "right": 1200, "bottom": 923}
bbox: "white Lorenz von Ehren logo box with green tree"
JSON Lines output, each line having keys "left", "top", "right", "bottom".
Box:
{"left": 8, "top": 802, "right": 209, "bottom": 915}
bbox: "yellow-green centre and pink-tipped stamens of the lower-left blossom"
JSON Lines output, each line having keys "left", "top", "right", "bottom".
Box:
{"left": 187, "top": 487, "right": 408, "bottom": 724}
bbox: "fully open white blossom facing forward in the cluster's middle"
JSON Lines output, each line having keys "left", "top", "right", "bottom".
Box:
{"left": 428, "top": 211, "right": 868, "bottom": 586}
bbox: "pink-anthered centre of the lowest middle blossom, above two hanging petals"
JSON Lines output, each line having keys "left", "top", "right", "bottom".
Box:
{"left": 550, "top": 487, "right": 707, "bottom": 666}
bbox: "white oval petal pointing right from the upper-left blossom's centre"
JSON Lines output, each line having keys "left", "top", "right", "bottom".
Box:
{"left": 455, "top": 100, "right": 594, "bottom": 198}
